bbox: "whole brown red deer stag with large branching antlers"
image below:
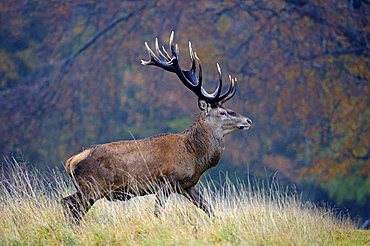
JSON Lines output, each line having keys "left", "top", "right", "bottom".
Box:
{"left": 62, "top": 32, "right": 252, "bottom": 222}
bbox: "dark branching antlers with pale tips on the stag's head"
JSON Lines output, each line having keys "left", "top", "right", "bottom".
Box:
{"left": 141, "top": 32, "right": 236, "bottom": 107}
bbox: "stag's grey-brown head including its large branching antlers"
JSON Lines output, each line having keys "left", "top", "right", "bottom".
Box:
{"left": 141, "top": 32, "right": 252, "bottom": 135}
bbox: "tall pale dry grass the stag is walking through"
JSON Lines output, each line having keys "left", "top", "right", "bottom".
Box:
{"left": 0, "top": 160, "right": 370, "bottom": 245}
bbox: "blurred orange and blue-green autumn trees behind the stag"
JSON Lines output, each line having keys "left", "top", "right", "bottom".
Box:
{"left": 0, "top": 0, "right": 370, "bottom": 217}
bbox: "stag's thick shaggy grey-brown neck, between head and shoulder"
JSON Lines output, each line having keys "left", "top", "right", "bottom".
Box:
{"left": 185, "top": 115, "right": 224, "bottom": 170}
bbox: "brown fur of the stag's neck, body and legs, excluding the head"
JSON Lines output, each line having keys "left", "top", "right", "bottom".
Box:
{"left": 63, "top": 115, "right": 237, "bottom": 221}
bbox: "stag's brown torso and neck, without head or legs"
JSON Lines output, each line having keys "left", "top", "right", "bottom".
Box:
{"left": 66, "top": 116, "right": 224, "bottom": 195}
